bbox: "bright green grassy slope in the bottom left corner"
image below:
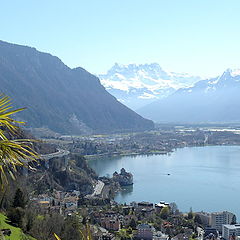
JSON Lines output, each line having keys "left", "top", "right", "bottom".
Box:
{"left": 0, "top": 214, "right": 36, "bottom": 240}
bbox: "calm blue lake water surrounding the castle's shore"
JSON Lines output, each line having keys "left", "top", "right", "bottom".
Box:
{"left": 89, "top": 146, "right": 240, "bottom": 219}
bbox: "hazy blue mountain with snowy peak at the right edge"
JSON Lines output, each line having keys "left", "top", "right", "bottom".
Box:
{"left": 138, "top": 69, "right": 240, "bottom": 122}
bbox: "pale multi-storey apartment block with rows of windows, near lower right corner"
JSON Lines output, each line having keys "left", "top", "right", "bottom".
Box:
{"left": 210, "top": 211, "right": 235, "bottom": 232}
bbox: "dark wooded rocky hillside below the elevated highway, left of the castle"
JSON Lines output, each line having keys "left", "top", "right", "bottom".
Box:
{"left": 27, "top": 154, "right": 97, "bottom": 195}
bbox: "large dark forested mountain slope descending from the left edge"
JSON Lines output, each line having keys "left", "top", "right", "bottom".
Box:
{"left": 0, "top": 41, "right": 153, "bottom": 134}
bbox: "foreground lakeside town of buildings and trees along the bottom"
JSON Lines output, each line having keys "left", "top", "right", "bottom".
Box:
{"left": 31, "top": 187, "right": 240, "bottom": 240}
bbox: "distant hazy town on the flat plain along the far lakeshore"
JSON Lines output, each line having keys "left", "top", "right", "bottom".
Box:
{"left": 31, "top": 125, "right": 240, "bottom": 158}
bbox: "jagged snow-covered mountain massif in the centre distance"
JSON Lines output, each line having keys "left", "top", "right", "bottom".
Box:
{"left": 99, "top": 63, "right": 200, "bottom": 110}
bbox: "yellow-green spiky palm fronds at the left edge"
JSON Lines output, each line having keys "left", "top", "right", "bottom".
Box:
{"left": 0, "top": 94, "right": 39, "bottom": 188}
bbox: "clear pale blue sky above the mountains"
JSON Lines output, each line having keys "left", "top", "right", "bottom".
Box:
{"left": 0, "top": 0, "right": 240, "bottom": 77}
